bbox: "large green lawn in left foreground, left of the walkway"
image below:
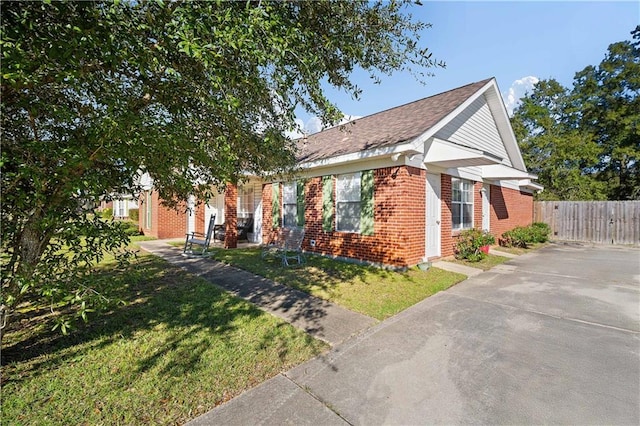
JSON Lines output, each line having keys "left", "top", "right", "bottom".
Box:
{"left": 1, "top": 256, "right": 327, "bottom": 425}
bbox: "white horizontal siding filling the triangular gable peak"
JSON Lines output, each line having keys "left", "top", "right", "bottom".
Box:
{"left": 435, "top": 95, "right": 512, "bottom": 166}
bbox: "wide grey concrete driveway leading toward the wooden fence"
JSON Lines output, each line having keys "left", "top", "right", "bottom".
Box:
{"left": 191, "top": 244, "right": 640, "bottom": 425}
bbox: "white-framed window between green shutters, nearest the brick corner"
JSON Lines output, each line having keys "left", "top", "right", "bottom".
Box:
{"left": 336, "top": 172, "right": 361, "bottom": 232}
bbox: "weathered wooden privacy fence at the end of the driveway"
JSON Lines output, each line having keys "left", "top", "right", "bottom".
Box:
{"left": 533, "top": 201, "right": 640, "bottom": 245}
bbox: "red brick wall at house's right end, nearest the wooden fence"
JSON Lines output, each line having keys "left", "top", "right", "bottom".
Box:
{"left": 490, "top": 185, "right": 533, "bottom": 241}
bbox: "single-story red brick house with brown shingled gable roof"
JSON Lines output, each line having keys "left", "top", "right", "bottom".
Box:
{"left": 140, "top": 79, "right": 542, "bottom": 267}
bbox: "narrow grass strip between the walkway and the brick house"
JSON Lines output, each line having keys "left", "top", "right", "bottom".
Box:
{"left": 213, "top": 248, "right": 466, "bottom": 320}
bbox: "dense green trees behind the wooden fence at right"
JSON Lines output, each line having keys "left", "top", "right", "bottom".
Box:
{"left": 512, "top": 26, "right": 640, "bottom": 200}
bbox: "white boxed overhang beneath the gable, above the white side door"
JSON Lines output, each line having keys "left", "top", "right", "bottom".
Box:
{"left": 424, "top": 138, "right": 502, "bottom": 168}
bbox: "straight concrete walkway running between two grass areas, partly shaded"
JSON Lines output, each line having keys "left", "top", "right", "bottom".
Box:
{"left": 138, "top": 240, "right": 378, "bottom": 346}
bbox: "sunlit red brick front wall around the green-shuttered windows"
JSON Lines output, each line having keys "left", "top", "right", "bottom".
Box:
{"left": 262, "top": 166, "right": 426, "bottom": 266}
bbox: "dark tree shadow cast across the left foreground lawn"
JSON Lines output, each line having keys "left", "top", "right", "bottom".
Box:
{"left": 2, "top": 256, "right": 287, "bottom": 383}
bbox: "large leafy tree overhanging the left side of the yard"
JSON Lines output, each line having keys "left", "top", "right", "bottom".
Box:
{"left": 0, "top": 0, "right": 442, "bottom": 332}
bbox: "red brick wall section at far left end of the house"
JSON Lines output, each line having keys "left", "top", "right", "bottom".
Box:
{"left": 139, "top": 191, "right": 187, "bottom": 239}
